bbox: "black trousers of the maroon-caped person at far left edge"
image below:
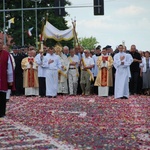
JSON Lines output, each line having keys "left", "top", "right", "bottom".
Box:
{"left": 0, "top": 92, "right": 6, "bottom": 117}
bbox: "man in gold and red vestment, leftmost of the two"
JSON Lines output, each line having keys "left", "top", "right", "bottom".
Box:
{"left": 21, "top": 50, "right": 39, "bottom": 97}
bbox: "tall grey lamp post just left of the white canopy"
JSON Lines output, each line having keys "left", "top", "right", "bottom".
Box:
{"left": 31, "top": 0, "right": 41, "bottom": 49}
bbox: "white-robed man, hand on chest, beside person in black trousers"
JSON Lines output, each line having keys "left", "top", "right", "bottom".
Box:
{"left": 43, "top": 48, "right": 63, "bottom": 98}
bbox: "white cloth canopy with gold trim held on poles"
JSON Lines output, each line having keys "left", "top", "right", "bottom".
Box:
{"left": 43, "top": 21, "right": 73, "bottom": 41}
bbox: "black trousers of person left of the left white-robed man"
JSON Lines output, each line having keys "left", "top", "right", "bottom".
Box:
{"left": 38, "top": 77, "right": 46, "bottom": 96}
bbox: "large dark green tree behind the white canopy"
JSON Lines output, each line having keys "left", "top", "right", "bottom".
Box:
{"left": 0, "top": 0, "right": 73, "bottom": 47}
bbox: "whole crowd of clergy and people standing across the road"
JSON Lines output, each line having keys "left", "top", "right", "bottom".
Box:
{"left": 0, "top": 39, "right": 150, "bottom": 117}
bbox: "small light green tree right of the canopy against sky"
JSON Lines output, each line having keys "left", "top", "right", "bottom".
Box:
{"left": 79, "top": 36, "right": 98, "bottom": 50}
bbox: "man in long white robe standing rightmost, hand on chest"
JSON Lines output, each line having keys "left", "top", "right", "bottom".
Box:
{"left": 114, "top": 45, "right": 133, "bottom": 99}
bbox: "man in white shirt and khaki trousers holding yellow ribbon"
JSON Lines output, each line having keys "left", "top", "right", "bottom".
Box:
{"left": 80, "top": 50, "right": 94, "bottom": 95}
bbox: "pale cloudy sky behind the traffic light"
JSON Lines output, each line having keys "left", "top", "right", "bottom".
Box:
{"left": 66, "top": 0, "right": 150, "bottom": 51}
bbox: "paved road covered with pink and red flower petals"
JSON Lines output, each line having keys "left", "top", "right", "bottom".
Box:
{"left": 0, "top": 96, "right": 150, "bottom": 150}
